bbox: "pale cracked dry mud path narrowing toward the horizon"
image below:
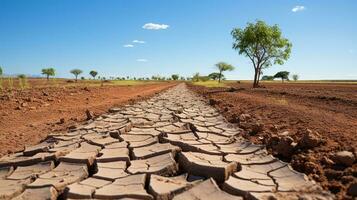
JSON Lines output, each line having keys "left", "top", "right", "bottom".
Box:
{"left": 0, "top": 84, "right": 334, "bottom": 200}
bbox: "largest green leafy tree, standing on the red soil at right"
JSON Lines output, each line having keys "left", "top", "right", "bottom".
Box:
{"left": 231, "top": 21, "right": 292, "bottom": 87}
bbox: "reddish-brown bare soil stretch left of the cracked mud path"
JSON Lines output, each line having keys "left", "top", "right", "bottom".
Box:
{"left": 0, "top": 81, "right": 174, "bottom": 155}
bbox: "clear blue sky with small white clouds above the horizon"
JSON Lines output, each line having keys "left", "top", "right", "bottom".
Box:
{"left": 0, "top": 0, "right": 357, "bottom": 79}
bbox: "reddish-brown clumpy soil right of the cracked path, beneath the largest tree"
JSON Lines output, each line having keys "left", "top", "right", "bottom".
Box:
{"left": 190, "top": 83, "right": 357, "bottom": 199}
